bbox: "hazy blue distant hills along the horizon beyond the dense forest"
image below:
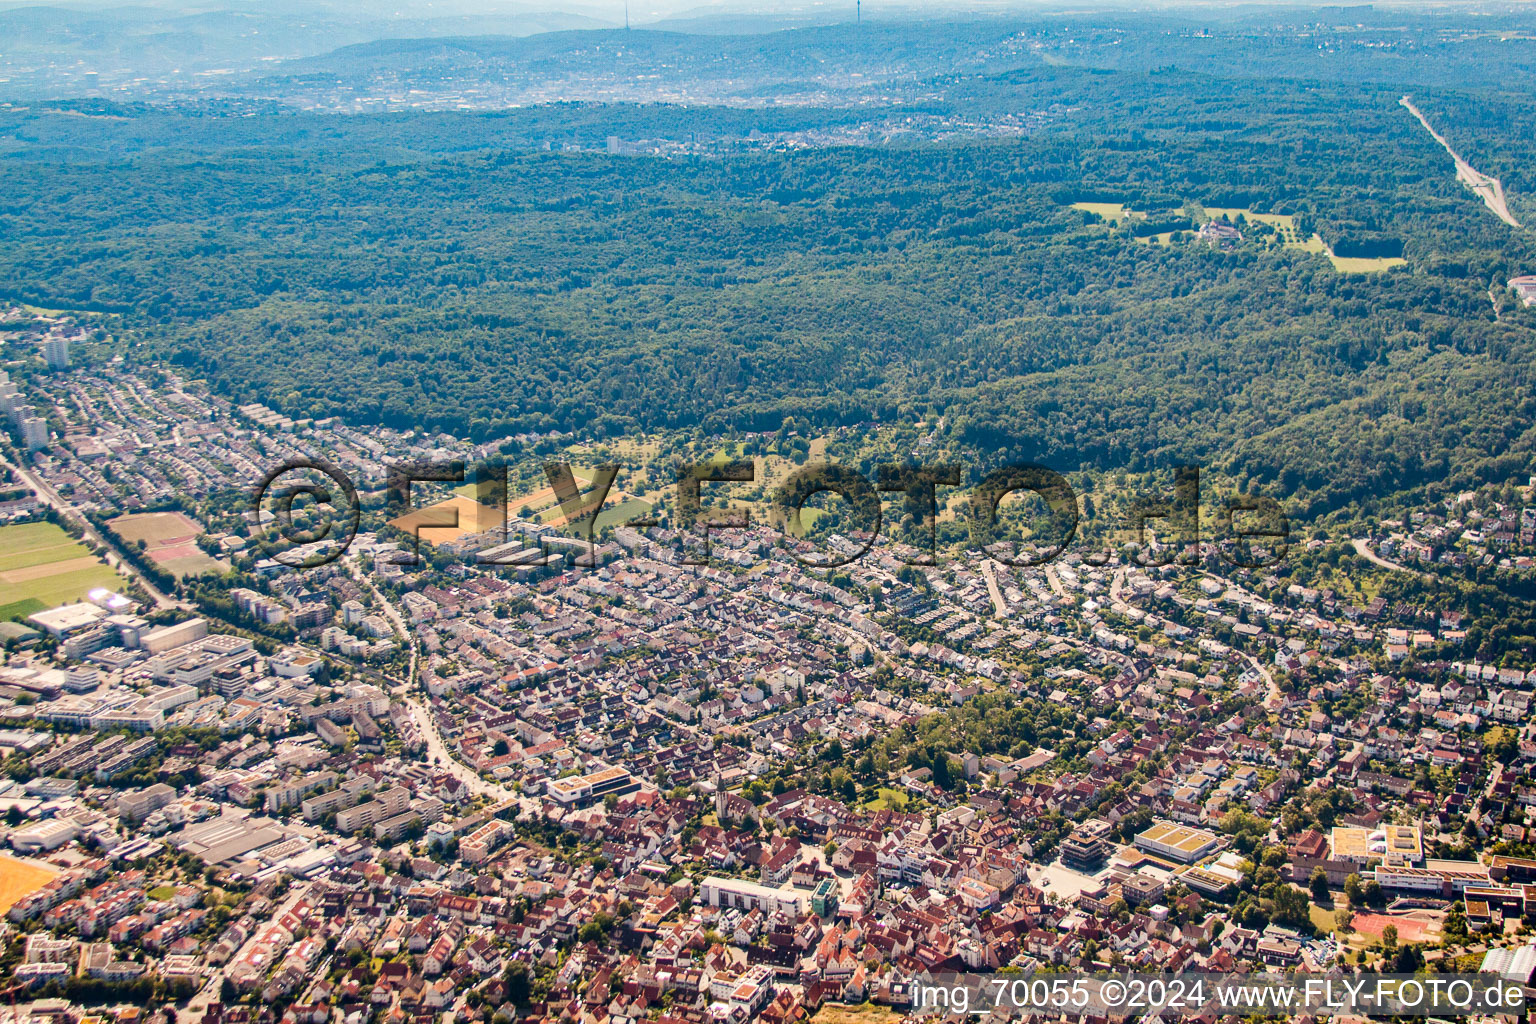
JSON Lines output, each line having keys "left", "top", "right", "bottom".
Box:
{"left": 158, "top": 6, "right": 1536, "bottom": 109}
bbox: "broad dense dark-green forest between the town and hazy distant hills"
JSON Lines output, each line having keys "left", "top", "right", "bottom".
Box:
{"left": 0, "top": 14, "right": 1536, "bottom": 528}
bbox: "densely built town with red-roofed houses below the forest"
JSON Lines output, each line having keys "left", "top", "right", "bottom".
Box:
{"left": 0, "top": 310, "right": 1536, "bottom": 1024}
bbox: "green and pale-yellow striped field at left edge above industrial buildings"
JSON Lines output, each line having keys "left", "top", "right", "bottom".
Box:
{"left": 0, "top": 522, "right": 126, "bottom": 620}
